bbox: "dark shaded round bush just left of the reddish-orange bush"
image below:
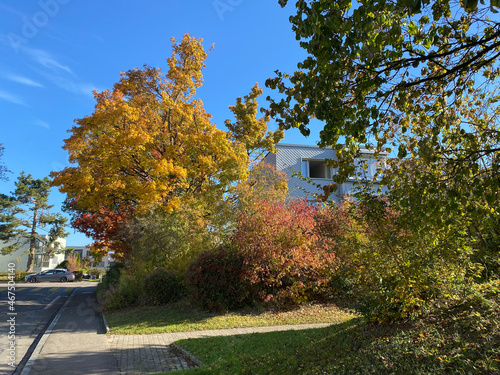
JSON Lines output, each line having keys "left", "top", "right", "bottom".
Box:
{"left": 186, "top": 249, "right": 253, "bottom": 311}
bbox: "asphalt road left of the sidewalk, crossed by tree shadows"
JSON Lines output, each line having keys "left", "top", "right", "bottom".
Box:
{"left": 0, "top": 282, "right": 87, "bottom": 374}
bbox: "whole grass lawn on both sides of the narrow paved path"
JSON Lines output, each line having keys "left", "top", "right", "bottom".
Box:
{"left": 107, "top": 281, "right": 500, "bottom": 375}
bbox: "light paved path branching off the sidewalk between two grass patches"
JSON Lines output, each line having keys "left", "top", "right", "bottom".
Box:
{"left": 108, "top": 323, "right": 330, "bottom": 375}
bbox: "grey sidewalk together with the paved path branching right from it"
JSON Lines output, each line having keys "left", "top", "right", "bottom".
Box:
{"left": 14, "top": 288, "right": 329, "bottom": 375}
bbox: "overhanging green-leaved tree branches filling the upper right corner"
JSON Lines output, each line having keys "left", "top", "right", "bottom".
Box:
{"left": 266, "top": 0, "right": 500, "bottom": 254}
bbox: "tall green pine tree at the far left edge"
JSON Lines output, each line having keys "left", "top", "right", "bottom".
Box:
{"left": 0, "top": 172, "right": 68, "bottom": 272}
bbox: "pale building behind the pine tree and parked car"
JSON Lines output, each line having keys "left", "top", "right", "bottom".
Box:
{"left": 0, "top": 237, "right": 66, "bottom": 272}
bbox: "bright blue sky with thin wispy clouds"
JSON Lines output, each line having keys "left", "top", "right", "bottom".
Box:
{"left": 0, "top": 0, "right": 319, "bottom": 246}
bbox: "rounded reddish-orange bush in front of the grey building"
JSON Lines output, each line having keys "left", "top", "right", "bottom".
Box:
{"left": 232, "top": 201, "right": 336, "bottom": 307}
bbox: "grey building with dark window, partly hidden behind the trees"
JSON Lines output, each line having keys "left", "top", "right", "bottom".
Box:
{"left": 264, "top": 144, "right": 386, "bottom": 201}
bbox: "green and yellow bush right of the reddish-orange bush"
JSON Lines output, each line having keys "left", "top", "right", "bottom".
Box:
{"left": 318, "top": 196, "right": 473, "bottom": 322}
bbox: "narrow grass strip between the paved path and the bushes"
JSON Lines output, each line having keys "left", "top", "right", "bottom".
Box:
{"left": 105, "top": 301, "right": 355, "bottom": 335}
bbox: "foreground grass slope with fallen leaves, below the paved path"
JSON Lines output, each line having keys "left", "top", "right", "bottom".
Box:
{"left": 166, "top": 282, "right": 500, "bottom": 375}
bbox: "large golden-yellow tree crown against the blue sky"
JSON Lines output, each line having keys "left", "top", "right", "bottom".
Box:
{"left": 52, "top": 35, "right": 248, "bottom": 256}
